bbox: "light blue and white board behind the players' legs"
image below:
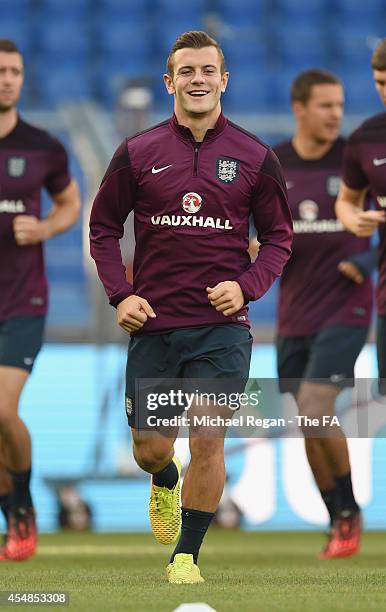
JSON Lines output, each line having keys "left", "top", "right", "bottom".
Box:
{"left": 10, "top": 344, "right": 386, "bottom": 531}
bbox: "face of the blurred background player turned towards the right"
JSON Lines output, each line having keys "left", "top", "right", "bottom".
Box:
{"left": 293, "top": 83, "right": 344, "bottom": 144}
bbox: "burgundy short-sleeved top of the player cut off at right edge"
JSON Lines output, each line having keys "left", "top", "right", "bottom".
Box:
{"left": 343, "top": 113, "right": 386, "bottom": 317}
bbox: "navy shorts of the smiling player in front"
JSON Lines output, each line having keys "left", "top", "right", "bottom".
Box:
{"left": 125, "top": 323, "right": 252, "bottom": 428}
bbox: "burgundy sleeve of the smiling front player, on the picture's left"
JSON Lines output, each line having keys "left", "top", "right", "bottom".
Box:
{"left": 90, "top": 141, "right": 135, "bottom": 307}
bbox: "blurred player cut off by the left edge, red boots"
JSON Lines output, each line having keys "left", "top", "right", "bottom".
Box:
{"left": 0, "top": 39, "right": 80, "bottom": 561}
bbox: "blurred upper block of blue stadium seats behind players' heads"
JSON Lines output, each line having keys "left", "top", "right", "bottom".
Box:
{"left": 0, "top": 0, "right": 380, "bottom": 120}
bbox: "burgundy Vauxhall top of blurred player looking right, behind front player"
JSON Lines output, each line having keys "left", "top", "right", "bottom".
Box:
{"left": 275, "top": 138, "right": 372, "bottom": 336}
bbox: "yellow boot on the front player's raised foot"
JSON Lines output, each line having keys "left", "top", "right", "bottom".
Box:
{"left": 149, "top": 456, "right": 181, "bottom": 544}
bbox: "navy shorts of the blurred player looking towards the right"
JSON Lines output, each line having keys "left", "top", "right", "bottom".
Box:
{"left": 276, "top": 325, "right": 368, "bottom": 395}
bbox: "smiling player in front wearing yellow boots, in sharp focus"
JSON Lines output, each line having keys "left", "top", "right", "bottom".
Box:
{"left": 90, "top": 32, "right": 292, "bottom": 583}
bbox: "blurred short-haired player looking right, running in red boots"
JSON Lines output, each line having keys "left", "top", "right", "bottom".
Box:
{"left": 274, "top": 69, "right": 372, "bottom": 559}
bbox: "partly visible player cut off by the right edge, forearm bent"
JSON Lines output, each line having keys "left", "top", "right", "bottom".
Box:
{"left": 336, "top": 38, "right": 386, "bottom": 395}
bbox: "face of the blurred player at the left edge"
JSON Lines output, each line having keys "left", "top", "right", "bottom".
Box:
{"left": 0, "top": 51, "right": 23, "bottom": 113}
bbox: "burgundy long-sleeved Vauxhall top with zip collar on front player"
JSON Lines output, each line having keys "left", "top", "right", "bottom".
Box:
{"left": 90, "top": 114, "right": 292, "bottom": 333}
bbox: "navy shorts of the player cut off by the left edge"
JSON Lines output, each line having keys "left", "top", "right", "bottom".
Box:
{"left": 0, "top": 315, "right": 45, "bottom": 372}
